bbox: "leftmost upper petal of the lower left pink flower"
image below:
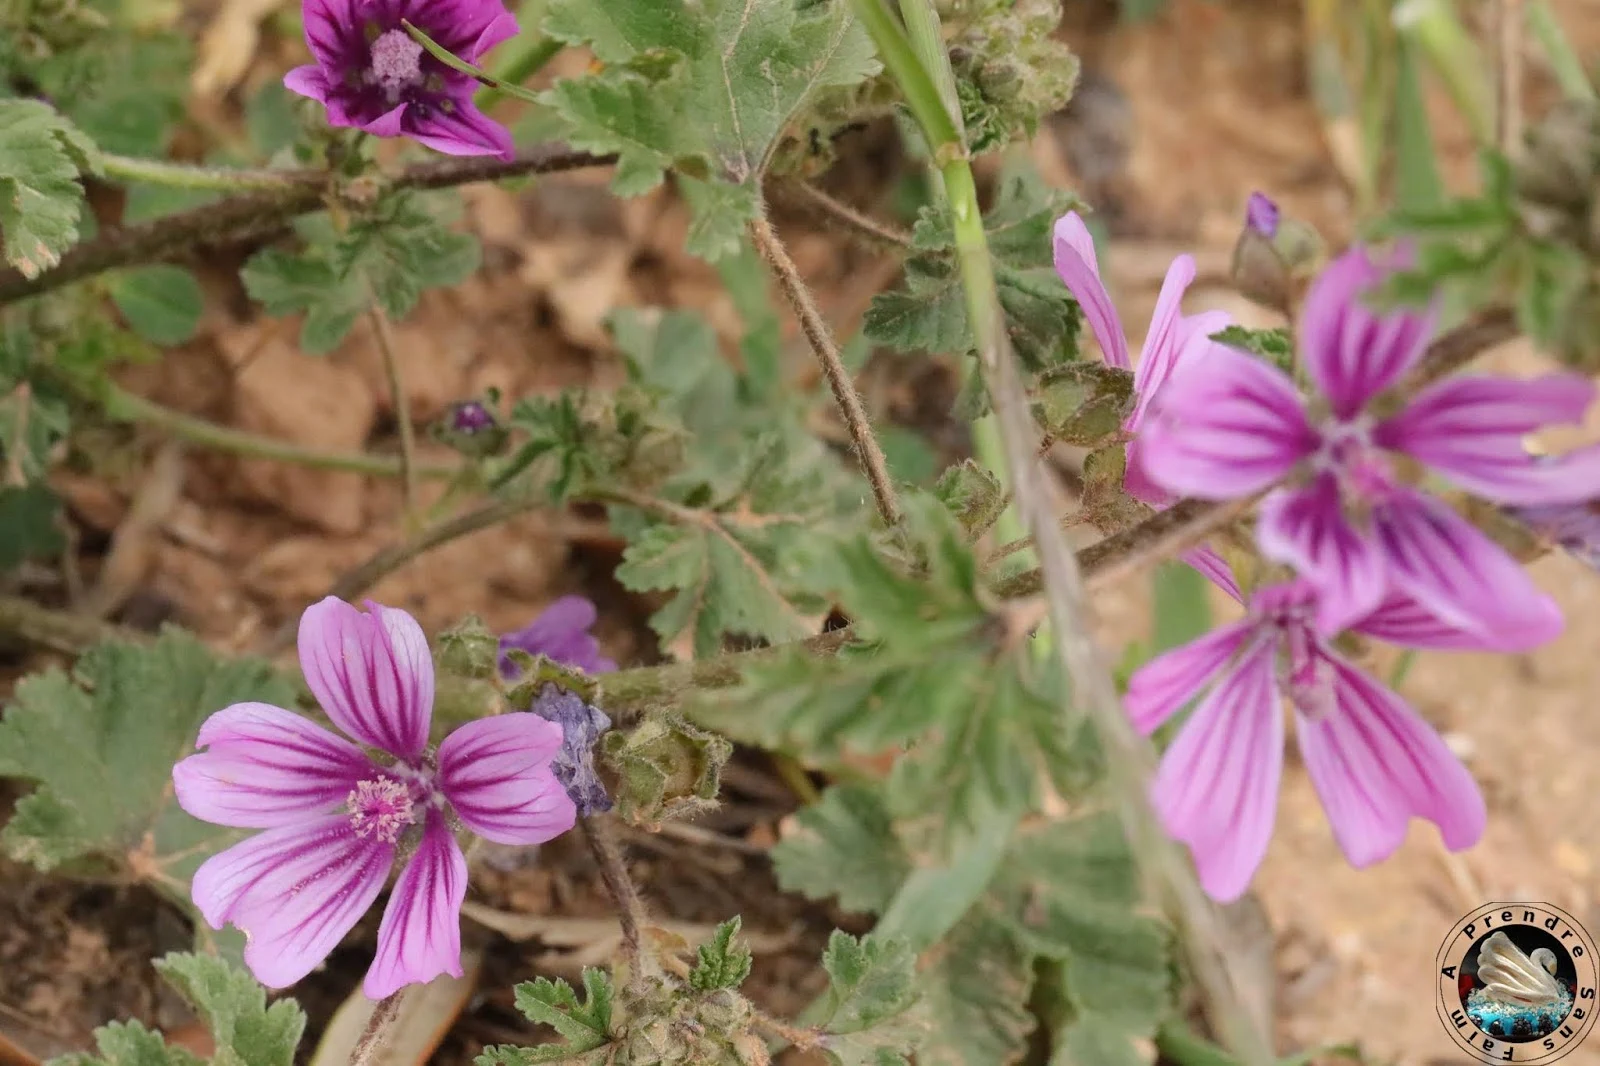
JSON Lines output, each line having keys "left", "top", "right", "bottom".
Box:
{"left": 173, "top": 703, "right": 373, "bottom": 829}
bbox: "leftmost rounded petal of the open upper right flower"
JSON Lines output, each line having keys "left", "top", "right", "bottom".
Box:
{"left": 1139, "top": 346, "right": 1318, "bottom": 499}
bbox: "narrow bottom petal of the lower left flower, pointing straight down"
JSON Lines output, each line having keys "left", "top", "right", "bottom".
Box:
{"left": 362, "top": 812, "right": 467, "bottom": 1000}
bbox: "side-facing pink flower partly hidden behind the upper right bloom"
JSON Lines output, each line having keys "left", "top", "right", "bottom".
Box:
{"left": 1054, "top": 211, "right": 1232, "bottom": 587}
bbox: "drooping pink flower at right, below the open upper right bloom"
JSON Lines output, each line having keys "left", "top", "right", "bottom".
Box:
{"left": 1126, "top": 579, "right": 1484, "bottom": 903}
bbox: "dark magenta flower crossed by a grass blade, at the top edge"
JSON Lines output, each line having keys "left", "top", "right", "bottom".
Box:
{"left": 283, "top": 0, "right": 517, "bottom": 158}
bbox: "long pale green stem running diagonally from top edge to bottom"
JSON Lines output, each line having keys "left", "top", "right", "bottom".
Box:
{"left": 853, "top": 0, "right": 1272, "bottom": 1066}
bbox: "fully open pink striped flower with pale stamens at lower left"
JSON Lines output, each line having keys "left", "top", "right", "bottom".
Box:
{"left": 173, "top": 597, "right": 576, "bottom": 999}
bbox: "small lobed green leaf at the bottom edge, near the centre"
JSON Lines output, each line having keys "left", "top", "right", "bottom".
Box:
{"left": 822, "top": 930, "right": 926, "bottom": 1066}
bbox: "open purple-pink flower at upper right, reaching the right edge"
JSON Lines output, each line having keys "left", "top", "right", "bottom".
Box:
{"left": 1141, "top": 250, "right": 1600, "bottom": 635}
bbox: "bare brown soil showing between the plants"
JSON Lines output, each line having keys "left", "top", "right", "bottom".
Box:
{"left": 0, "top": 0, "right": 1600, "bottom": 1066}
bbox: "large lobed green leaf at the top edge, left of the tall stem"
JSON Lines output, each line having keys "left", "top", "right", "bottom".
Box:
{"left": 542, "top": 0, "right": 878, "bottom": 259}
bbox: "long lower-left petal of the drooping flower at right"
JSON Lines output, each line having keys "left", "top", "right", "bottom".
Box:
{"left": 1150, "top": 643, "right": 1283, "bottom": 903}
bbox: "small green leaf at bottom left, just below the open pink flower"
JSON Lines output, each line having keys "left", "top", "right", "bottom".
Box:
{"left": 155, "top": 954, "right": 306, "bottom": 1066}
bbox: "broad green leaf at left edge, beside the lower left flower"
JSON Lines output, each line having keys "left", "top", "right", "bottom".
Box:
{"left": 0, "top": 631, "right": 294, "bottom": 900}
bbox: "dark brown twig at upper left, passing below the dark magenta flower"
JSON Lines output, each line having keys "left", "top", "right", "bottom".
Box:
{"left": 0, "top": 146, "right": 616, "bottom": 306}
